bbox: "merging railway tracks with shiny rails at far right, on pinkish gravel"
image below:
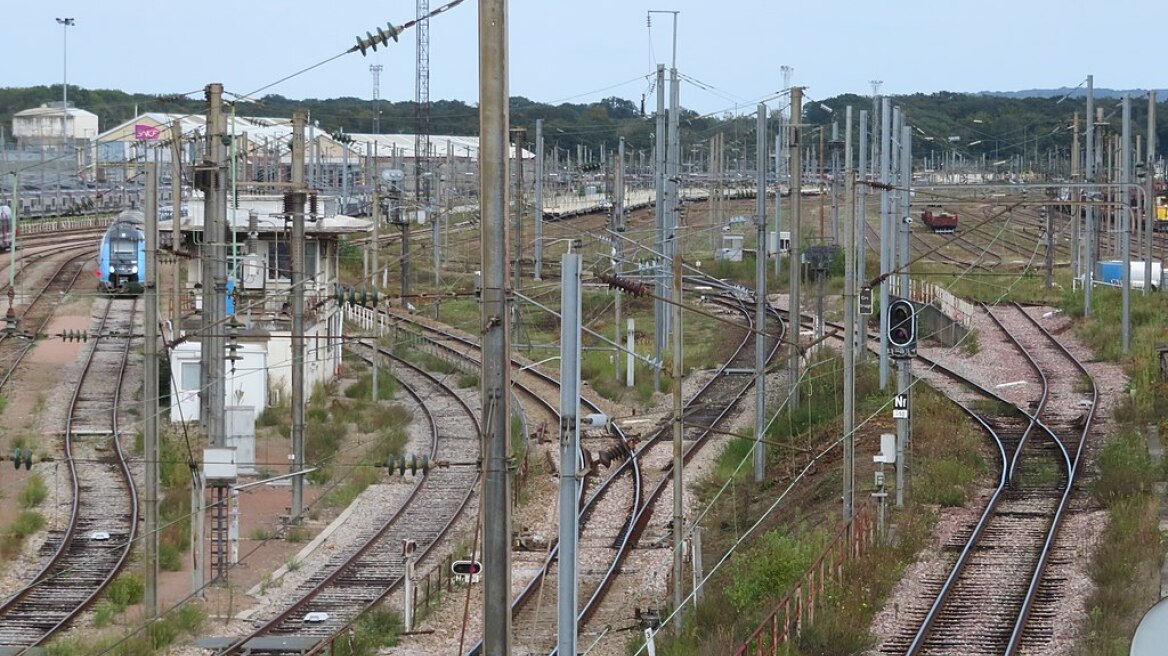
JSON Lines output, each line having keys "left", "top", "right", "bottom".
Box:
{"left": 881, "top": 305, "right": 1097, "bottom": 656}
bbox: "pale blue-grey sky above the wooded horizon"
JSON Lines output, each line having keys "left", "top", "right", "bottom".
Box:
{"left": 0, "top": 0, "right": 1168, "bottom": 113}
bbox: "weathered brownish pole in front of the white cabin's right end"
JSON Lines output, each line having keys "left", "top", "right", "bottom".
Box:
{"left": 285, "top": 111, "right": 308, "bottom": 521}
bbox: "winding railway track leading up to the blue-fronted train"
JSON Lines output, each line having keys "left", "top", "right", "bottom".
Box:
{"left": 0, "top": 295, "right": 140, "bottom": 652}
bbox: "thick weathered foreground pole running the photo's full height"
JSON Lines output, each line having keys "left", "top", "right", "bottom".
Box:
{"left": 479, "top": 0, "right": 512, "bottom": 644}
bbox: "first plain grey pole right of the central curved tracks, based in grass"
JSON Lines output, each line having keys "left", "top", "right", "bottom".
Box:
{"left": 755, "top": 103, "right": 766, "bottom": 483}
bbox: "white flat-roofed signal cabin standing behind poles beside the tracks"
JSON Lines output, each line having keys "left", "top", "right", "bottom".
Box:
{"left": 159, "top": 196, "right": 373, "bottom": 421}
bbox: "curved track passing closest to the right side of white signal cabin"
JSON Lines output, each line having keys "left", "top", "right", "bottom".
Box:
{"left": 216, "top": 344, "right": 479, "bottom": 656}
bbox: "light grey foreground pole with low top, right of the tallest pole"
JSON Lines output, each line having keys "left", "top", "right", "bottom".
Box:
{"left": 556, "top": 253, "right": 576, "bottom": 655}
